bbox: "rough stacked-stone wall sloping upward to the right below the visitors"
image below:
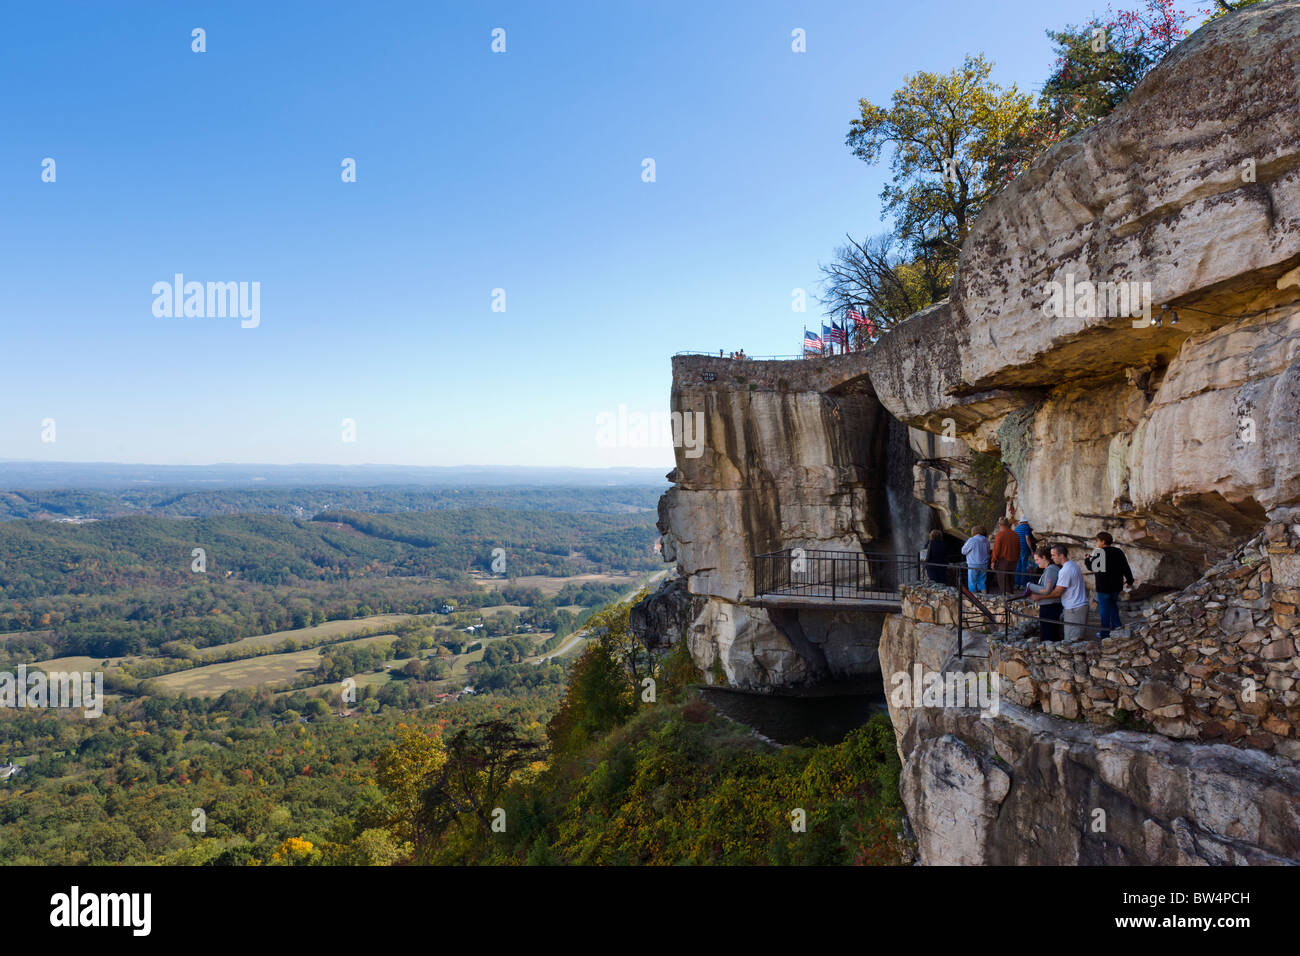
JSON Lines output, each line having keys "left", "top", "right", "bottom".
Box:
{"left": 989, "top": 520, "right": 1300, "bottom": 758}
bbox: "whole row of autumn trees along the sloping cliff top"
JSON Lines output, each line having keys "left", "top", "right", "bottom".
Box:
{"left": 819, "top": 0, "right": 1196, "bottom": 346}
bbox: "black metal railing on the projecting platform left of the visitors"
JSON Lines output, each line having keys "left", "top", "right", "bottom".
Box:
{"left": 754, "top": 548, "right": 922, "bottom": 601}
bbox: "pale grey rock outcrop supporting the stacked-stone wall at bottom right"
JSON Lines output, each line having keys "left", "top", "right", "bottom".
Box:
{"left": 880, "top": 588, "right": 1300, "bottom": 865}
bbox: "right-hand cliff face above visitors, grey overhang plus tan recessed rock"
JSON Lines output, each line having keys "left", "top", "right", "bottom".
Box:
{"left": 868, "top": 1, "right": 1300, "bottom": 574}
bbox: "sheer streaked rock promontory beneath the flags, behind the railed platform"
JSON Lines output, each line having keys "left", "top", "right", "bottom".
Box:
{"left": 634, "top": 356, "right": 911, "bottom": 689}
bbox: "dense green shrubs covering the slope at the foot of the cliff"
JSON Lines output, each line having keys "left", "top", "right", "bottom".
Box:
{"left": 426, "top": 700, "right": 906, "bottom": 865}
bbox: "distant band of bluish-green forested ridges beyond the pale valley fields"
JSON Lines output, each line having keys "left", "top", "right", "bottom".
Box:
{"left": 0, "top": 489, "right": 662, "bottom": 661}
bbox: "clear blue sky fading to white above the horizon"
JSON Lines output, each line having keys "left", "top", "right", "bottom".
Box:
{"left": 0, "top": 0, "right": 1138, "bottom": 470}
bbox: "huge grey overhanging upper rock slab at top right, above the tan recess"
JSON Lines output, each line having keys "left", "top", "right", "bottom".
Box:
{"left": 953, "top": 3, "right": 1300, "bottom": 389}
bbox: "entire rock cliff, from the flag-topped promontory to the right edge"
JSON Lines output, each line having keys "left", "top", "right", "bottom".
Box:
{"left": 634, "top": 0, "right": 1300, "bottom": 864}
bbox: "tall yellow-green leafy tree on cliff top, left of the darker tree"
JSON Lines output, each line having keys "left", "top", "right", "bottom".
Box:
{"left": 845, "top": 55, "right": 1034, "bottom": 261}
